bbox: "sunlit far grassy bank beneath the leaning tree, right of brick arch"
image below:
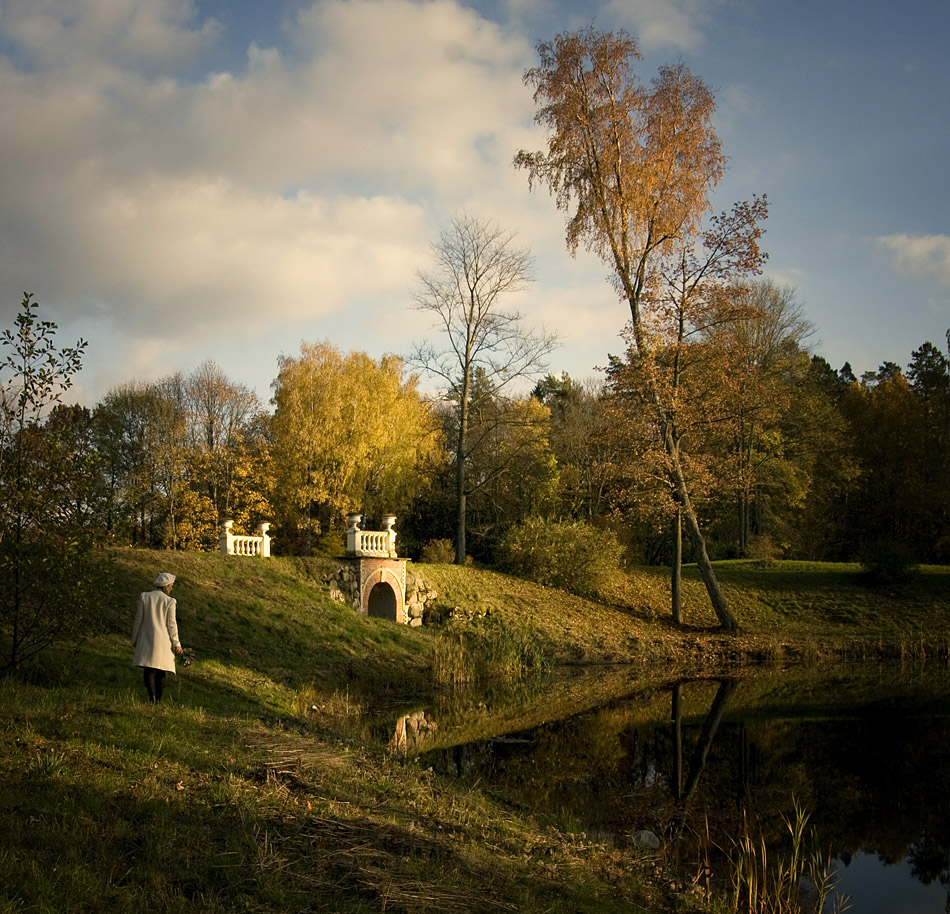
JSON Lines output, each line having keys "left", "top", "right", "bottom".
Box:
{"left": 420, "top": 562, "right": 950, "bottom": 670}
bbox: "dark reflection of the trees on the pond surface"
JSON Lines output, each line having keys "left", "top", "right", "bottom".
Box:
{"left": 425, "top": 668, "right": 950, "bottom": 885}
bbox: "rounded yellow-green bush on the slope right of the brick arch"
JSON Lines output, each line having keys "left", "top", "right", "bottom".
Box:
{"left": 497, "top": 517, "right": 622, "bottom": 597}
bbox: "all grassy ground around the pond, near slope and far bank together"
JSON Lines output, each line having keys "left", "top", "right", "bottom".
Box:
{"left": 0, "top": 550, "right": 950, "bottom": 914}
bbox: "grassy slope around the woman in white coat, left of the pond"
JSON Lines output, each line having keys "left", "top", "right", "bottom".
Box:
{"left": 0, "top": 550, "right": 688, "bottom": 914}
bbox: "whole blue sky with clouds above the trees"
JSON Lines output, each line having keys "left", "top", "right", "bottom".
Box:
{"left": 0, "top": 0, "right": 950, "bottom": 406}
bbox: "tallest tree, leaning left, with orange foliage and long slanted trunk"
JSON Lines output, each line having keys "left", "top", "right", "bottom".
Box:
{"left": 515, "top": 29, "right": 765, "bottom": 631}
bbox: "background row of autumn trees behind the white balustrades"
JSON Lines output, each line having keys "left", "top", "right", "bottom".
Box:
{"left": 0, "top": 288, "right": 950, "bottom": 565}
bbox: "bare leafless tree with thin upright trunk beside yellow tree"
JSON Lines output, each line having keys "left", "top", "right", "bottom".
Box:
{"left": 412, "top": 213, "right": 557, "bottom": 564}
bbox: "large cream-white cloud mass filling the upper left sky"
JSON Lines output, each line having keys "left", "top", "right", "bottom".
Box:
{"left": 0, "top": 0, "right": 556, "bottom": 400}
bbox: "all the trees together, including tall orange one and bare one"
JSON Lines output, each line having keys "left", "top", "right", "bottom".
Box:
{"left": 0, "top": 28, "right": 950, "bottom": 644}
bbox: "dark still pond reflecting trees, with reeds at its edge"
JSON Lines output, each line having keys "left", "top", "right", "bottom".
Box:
{"left": 390, "top": 666, "right": 950, "bottom": 914}
